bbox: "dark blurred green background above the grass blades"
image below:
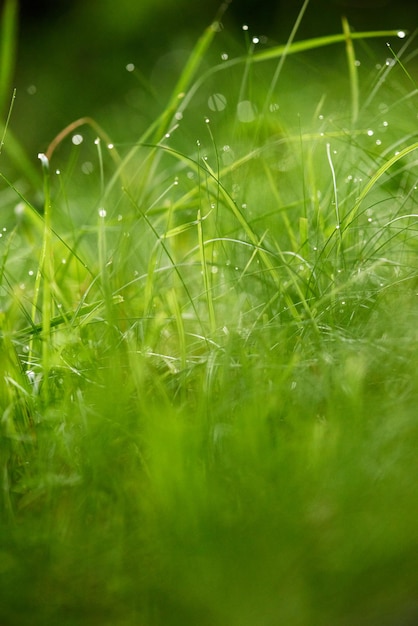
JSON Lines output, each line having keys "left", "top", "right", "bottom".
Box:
{"left": 11, "top": 0, "right": 418, "bottom": 161}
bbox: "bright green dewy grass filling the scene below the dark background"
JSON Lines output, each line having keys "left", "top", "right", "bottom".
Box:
{"left": 0, "top": 0, "right": 418, "bottom": 626}
